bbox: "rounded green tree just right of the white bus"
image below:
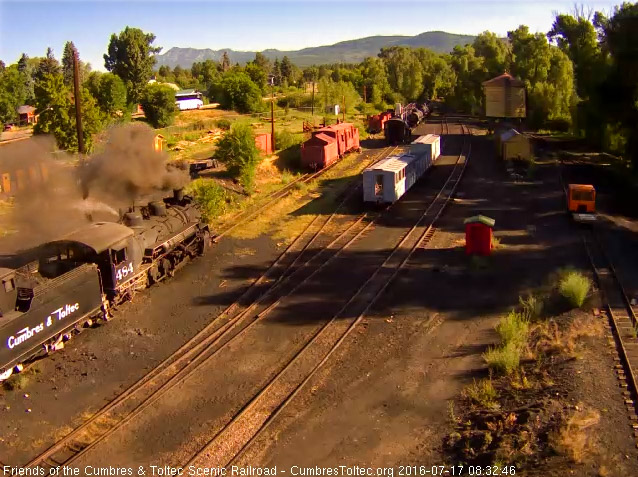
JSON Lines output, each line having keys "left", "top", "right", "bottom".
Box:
{"left": 209, "top": 71, "right": 263, "bottom": 113}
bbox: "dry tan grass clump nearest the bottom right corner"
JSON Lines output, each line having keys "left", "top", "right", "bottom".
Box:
{"left": 549, "top": 406, "right": 600, "bottom": 464}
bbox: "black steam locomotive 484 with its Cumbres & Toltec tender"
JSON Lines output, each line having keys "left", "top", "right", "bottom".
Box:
{"left": 0, "top": 190, "right": 211, "bottom": 380}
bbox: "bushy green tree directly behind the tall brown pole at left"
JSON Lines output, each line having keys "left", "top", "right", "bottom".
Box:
{"left": 34, "top": 74, "right": 102, "bottom": 152}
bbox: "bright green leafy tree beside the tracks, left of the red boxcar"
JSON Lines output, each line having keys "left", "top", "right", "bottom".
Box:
{"left": 214, "top": 124, "right": 261, "bottom": 194}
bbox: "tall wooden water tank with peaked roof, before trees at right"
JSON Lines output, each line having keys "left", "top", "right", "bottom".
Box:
{"left": 483, "top": 73, "right": 527, "bottom": 118}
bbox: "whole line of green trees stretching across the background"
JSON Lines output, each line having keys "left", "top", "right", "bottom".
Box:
{"left": 0, "top": 3, "right": 638, "bottom": 162}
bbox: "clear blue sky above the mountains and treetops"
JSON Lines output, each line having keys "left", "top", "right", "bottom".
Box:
{"left": 0, "top": 0, "right": 621, "bottom": 70}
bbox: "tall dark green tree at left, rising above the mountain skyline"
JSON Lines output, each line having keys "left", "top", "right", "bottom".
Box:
{"left": 104, "top": 26, "right": 162, "bottom": 103}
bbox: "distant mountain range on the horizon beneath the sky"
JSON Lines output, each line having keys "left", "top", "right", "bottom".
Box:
{"left": 156, "top": 31, "right": 475, "bottom": 68}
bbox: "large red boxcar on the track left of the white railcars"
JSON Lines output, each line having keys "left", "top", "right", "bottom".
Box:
{"left": 301, "top": 123, "right": 360, "bottom": 169}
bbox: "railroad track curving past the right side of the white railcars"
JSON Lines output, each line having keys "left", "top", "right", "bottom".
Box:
{"left": 184, "top": 125, "right": 471, "bottom": 467}
